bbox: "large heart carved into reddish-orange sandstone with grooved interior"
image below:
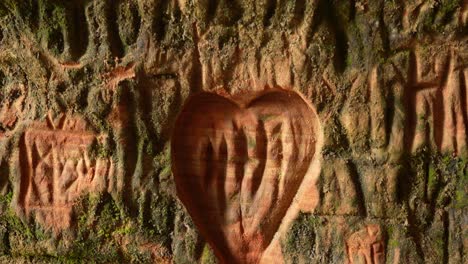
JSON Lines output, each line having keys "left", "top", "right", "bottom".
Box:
{"left": 172, "top": 89, "right": 316, "bottom": 263}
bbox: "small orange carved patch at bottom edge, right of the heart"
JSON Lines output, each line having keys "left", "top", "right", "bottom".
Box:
{"left": 346, "top": 225, "right": 385, "bottom": 264}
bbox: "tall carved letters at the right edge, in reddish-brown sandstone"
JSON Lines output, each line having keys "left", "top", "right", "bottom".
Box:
{"left": 406, "top": 51, "right": 468, "bottom": 154}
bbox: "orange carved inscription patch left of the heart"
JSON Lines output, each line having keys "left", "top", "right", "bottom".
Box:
{"left": 19, "top": 116, "right": 112, "bottom": 231}
